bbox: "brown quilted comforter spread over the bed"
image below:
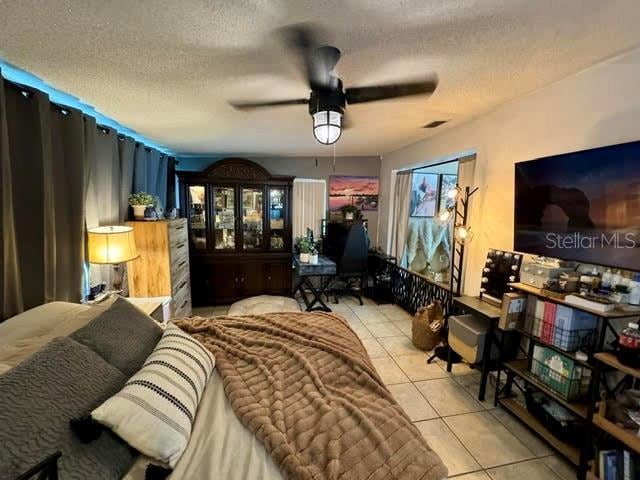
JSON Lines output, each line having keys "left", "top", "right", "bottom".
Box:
{"left": 176, "top": 312, "right": 447, "bottom": 480}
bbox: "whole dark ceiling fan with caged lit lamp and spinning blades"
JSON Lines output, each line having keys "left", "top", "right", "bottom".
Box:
{"left": 229, "top": 24, "right": 438, "bottom": 145}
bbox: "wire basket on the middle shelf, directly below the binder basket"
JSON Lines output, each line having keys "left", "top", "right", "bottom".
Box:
{"left": 531, "top": 345, "right": 591, "bottom": 401}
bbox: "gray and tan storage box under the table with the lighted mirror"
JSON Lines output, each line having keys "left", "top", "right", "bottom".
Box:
{"left": 449, "top": 315, "right": 499, "bottom": 364}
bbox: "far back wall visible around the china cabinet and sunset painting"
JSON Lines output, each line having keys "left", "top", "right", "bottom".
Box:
{"left": 179, "top": 156, "right": 380, "bottom": 246}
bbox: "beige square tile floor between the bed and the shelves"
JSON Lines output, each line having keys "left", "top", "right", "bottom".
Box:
{"left": 193, "top": 299, "right": 576, "bottom": 480}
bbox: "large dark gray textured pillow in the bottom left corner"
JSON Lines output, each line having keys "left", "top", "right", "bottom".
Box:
{"left": 0, "top": 337, "right": 136, "bottom": 480}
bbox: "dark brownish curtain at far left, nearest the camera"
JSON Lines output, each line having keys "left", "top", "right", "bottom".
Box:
{"left": 0, "top": 77, "right": 92, "bottom": 318}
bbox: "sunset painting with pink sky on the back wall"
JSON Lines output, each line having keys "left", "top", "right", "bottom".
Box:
{"left": 329, "top": 175, "right": 380, "bottom": 211}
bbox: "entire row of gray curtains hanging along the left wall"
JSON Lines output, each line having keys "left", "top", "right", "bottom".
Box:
{"left": 0, "top": 65, "right": 169, "bottom": 321}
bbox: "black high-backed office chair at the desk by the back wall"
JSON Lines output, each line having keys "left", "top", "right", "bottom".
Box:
{"left": 331, "top": 223, "right": 369, "bottom": 305}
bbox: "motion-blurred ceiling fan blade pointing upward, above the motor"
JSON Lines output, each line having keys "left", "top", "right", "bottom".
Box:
{"left": 280, "top": 23, "right": 340, "bottom": 90}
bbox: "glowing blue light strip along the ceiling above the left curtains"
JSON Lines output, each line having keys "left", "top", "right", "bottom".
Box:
{"left": 0, "top": 59, "right": 175, "bottom": 156}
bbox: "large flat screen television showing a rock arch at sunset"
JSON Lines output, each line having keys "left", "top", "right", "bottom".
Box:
{"left": 514, "top": 141, "right": 640, "bottom": 271}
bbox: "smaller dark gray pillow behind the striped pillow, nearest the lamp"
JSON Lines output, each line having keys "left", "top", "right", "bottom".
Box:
{"left": 71, "top": 297, "right": 162, "bottom": 377}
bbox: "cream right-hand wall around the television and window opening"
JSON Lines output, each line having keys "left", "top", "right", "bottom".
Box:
{"left": 379, "top": 49, "right": 640, "bottom": 294}
